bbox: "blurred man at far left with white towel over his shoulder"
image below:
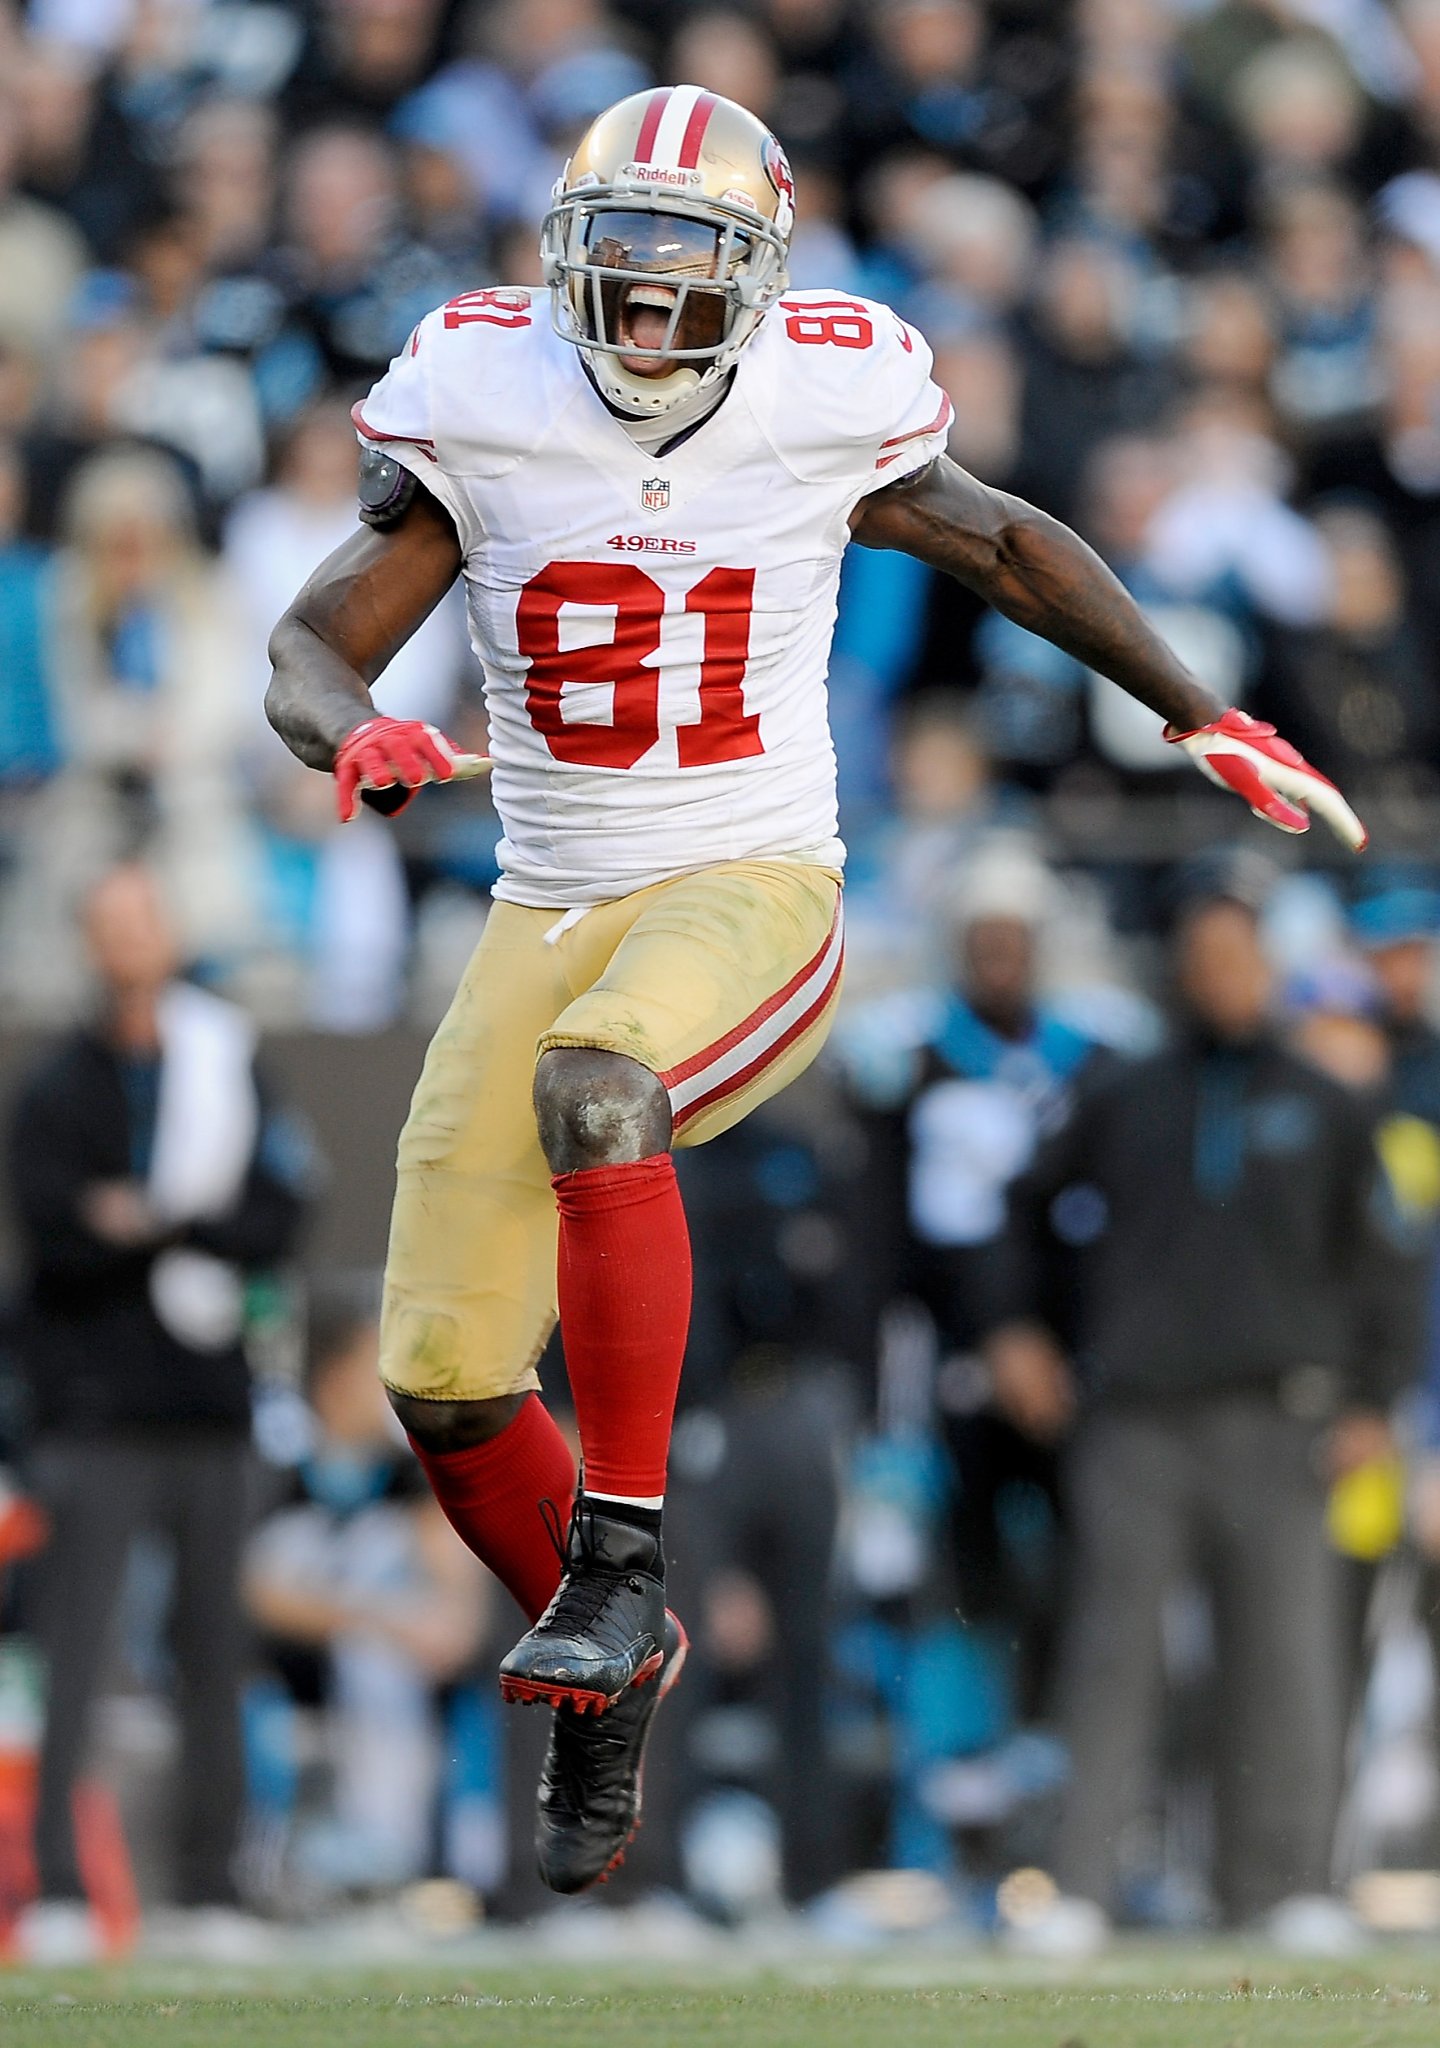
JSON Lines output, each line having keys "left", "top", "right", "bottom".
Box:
{"left": 6, "top": 866, "right": 311, "bottom": 1960}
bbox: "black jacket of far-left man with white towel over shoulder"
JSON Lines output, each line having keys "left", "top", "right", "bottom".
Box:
{"left": 8, "top": 1030, "right": 311, "bottom": 1434}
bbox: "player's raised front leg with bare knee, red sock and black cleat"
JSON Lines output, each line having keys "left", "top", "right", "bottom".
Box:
{"left": 502, "top": 862, "right": 840, "bottom": 1710}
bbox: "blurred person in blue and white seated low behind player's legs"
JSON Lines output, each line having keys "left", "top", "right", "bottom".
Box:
{"left": 244, "top": 1290, "right": 485, "bottom": 1890}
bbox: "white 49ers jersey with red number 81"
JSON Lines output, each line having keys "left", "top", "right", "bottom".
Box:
{"left": 354, "top": 289, "right": 950, "bottom": 909}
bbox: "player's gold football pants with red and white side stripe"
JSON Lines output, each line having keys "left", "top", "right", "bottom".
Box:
{"left": 381, "top": 860, "right": 842, "bottom": 1401}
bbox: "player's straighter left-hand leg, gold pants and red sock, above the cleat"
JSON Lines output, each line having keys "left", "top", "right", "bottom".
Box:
{"left": 381, "top": 903, "right": 576, "bottom": 1620}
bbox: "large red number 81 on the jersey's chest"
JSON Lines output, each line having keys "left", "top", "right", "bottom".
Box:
{"left": 516, "top": 561, "right": 764, "bottom": 768}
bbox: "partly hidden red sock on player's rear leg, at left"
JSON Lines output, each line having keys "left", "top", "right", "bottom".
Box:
{"left": 410, "top": 1395, "right": 576, "bottom": 1622}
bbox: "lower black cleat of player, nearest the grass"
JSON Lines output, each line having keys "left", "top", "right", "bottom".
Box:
{"left": 535, "top": 1614, "right": 690, "bottom": 1894}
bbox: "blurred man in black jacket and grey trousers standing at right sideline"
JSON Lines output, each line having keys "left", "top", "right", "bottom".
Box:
{"left": 987, "top": 877, "right": 1417, "bottom": 1950}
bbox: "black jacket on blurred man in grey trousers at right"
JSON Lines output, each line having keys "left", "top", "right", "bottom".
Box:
{"left": 993, "top": 1036, "right": 1415, "bottom": 1413}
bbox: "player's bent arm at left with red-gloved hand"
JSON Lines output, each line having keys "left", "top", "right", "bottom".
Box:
{"left": 264, "top": 489, "right": 461, "bottom": 815}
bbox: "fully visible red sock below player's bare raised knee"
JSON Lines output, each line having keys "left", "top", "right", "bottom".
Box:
{"left": 553, "top": 1153, "right": 690, "bottom": 1499}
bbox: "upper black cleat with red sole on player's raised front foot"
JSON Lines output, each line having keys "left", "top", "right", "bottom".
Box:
{"left": 500, "top": 1495, "right": 666, "bottom": 1714}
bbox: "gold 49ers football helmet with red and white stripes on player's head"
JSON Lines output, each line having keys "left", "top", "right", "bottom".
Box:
{"left": 541, "top": 86, "right": 795, "bottom": 418}
